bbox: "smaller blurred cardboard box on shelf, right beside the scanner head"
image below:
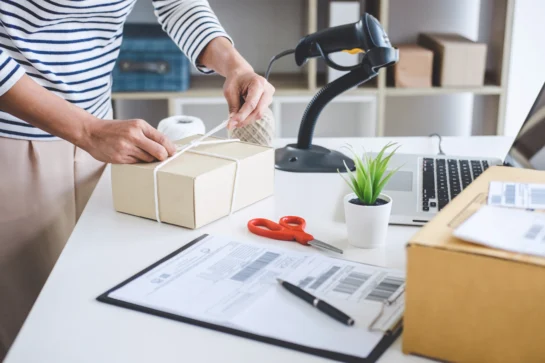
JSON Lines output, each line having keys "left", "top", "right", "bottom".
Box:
{"left": 391, "top": 44, "right": 433, "bottom": 88}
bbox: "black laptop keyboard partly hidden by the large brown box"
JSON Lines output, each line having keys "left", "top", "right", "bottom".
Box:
{"left": 422, "top": 158, "right": 489, "bottom": 212}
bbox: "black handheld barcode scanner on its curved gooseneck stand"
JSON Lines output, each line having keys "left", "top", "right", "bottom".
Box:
{"left": 267, "top": 13, "right": 399, "bottom": 173}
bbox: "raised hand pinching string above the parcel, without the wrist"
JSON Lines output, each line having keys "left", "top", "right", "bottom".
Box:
{"left": 223, "top": 68, "right": 274, "bottom": 129}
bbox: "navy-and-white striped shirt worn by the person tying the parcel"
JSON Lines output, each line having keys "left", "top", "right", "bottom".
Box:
{"left": 0, "top": 0, "right": 231, "bottom": 140}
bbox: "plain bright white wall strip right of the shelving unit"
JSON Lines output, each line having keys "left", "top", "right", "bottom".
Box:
{"left": 504, "top": 0, "right": 545, "bottom": 137}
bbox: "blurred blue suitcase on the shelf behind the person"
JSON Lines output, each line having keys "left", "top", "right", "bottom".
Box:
{"left": 112, "top": 24, "right": 191, "bottom": 92}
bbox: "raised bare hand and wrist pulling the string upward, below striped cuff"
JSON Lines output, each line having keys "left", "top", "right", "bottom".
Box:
{"left": 198, "top": 37, "right": 274, "bottom": 128}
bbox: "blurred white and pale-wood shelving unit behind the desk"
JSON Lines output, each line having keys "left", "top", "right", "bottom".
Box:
{"left": 113, "top": 0, "right": 515, "bottom": 137}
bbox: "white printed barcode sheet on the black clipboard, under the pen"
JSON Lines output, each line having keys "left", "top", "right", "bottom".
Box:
{"left": 109, "top": 236, "right": 405, "bottom": 357}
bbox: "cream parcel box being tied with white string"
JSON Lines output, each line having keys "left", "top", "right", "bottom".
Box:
{"left": 112, "top": 136, "right": 274, "bottom": 228}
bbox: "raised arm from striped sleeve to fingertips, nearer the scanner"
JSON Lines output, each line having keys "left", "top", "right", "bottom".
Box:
{"left": 153, "top": 0, "right": 274, "bottom": 128}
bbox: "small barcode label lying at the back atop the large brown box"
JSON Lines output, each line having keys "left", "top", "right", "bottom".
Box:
{"left": 488, "top": 181, "right": 545, "bottom": 209}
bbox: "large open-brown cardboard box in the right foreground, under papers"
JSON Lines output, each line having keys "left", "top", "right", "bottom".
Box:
{"left": 403, "top": 167, "right": 545, "bottom": 362}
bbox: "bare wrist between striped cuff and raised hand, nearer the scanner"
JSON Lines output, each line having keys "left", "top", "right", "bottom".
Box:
{"left": 198, "top": 37, "right": 253, "bottom": 77}
